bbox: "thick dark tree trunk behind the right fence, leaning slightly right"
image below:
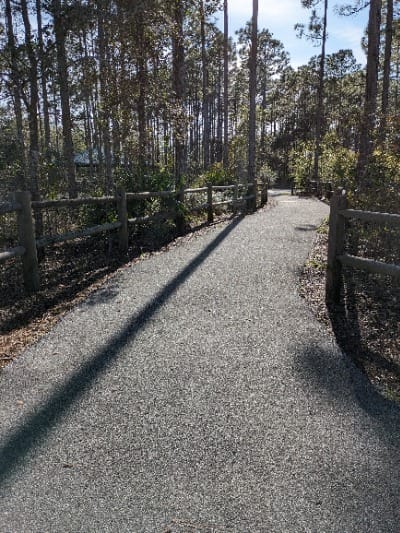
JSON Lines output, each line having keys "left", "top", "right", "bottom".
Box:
{"left": 357, "top": 0, "right": 382, "bottom": 189}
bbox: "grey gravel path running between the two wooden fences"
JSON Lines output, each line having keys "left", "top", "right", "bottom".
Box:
{"left": 0, "top": 194, "right": 400, "bottom": 533}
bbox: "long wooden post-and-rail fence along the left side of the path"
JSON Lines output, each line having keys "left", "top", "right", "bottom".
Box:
{"left": 0, "top": 183, "right": 268, "bottom": 292}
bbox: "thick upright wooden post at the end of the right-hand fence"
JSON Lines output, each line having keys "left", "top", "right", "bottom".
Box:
{"left": 326, "top": 189, "right": 347, "bottom": 304}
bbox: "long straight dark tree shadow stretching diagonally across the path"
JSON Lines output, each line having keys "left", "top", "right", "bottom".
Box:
{"left": 0, "top": 216, "right": 243, "bottom": 483}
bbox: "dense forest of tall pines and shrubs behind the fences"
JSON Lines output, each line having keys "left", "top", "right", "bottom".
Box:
{"left": 0, "top": 0, "right": 400, "bottom": 210}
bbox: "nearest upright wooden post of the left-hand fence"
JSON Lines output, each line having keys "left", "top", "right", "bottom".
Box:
{"left": 14, "top": 191, "right": 40, "bottom": 292}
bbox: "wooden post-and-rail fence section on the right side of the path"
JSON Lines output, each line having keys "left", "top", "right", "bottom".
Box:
{"left": 326, "top": 190, "right": 400, "bottom": 303}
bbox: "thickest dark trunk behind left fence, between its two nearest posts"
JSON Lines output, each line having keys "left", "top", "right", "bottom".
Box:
{"left": 51, "top": 0, "right": 78, "bottom": 198}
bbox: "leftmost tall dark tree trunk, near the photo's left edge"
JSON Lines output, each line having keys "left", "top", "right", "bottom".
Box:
{"left": 5, "top": 0, "right": 26, "bottom": 191}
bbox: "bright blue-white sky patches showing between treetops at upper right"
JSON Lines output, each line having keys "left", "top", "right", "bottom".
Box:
{"left": 216, "top": 0, "right": 368, "bottom": 68}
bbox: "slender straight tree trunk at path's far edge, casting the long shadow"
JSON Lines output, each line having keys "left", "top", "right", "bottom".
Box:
{"left": 248, "top": 0, "right": 258, "bottom": 209}
